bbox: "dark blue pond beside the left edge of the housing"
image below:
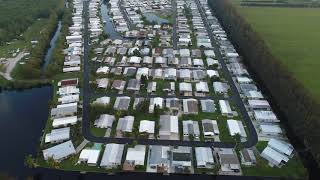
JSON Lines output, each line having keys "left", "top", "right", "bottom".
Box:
{"left": 0, "top": 86, "right": 52, "bottom": 176}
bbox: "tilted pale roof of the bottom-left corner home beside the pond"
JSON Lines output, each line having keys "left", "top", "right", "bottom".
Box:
{"left": 42, "top": 140, "right": 76, "bottom": 160}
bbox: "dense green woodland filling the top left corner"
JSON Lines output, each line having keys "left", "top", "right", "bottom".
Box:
{"left": 0, "top": 0, "right": 63, "bottom": 45}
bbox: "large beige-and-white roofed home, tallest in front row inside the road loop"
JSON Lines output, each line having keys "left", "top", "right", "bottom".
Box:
{"left": 159, "top": 115, "right": 179, "bottom": 140}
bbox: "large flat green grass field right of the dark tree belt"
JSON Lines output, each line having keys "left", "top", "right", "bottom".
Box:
{"left": 232, "top": 0, "right": 320, "bottom": 101}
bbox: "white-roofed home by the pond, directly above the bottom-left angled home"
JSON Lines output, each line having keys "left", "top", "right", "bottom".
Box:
{"left": 45, "top": 127, "right": 70, "bottom": 143}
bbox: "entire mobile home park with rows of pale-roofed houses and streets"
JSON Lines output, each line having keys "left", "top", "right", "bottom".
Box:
{"left": 37, "top": 0, "right": 306, "bottom": 176}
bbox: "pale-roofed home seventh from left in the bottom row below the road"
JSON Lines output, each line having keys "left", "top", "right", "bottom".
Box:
{"left": 195, "top": 147, "right": 214, "bottom": 168}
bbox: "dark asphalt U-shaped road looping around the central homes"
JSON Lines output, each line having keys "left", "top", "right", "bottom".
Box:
{"left": 82, "top": 0, "right": 258, "bottom": 148}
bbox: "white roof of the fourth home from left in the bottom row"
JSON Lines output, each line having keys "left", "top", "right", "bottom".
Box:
{"left": 126, "top": 145, "right": 146, "bottom": 165}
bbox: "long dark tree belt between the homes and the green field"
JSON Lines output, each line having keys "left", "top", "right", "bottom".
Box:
{"left": 209, "top": 0, "right": 320, "bottom": 165}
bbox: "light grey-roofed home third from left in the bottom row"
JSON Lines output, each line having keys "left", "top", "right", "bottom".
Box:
{"left": 100, "top": 143, "right": 124, "bottom": 169}
